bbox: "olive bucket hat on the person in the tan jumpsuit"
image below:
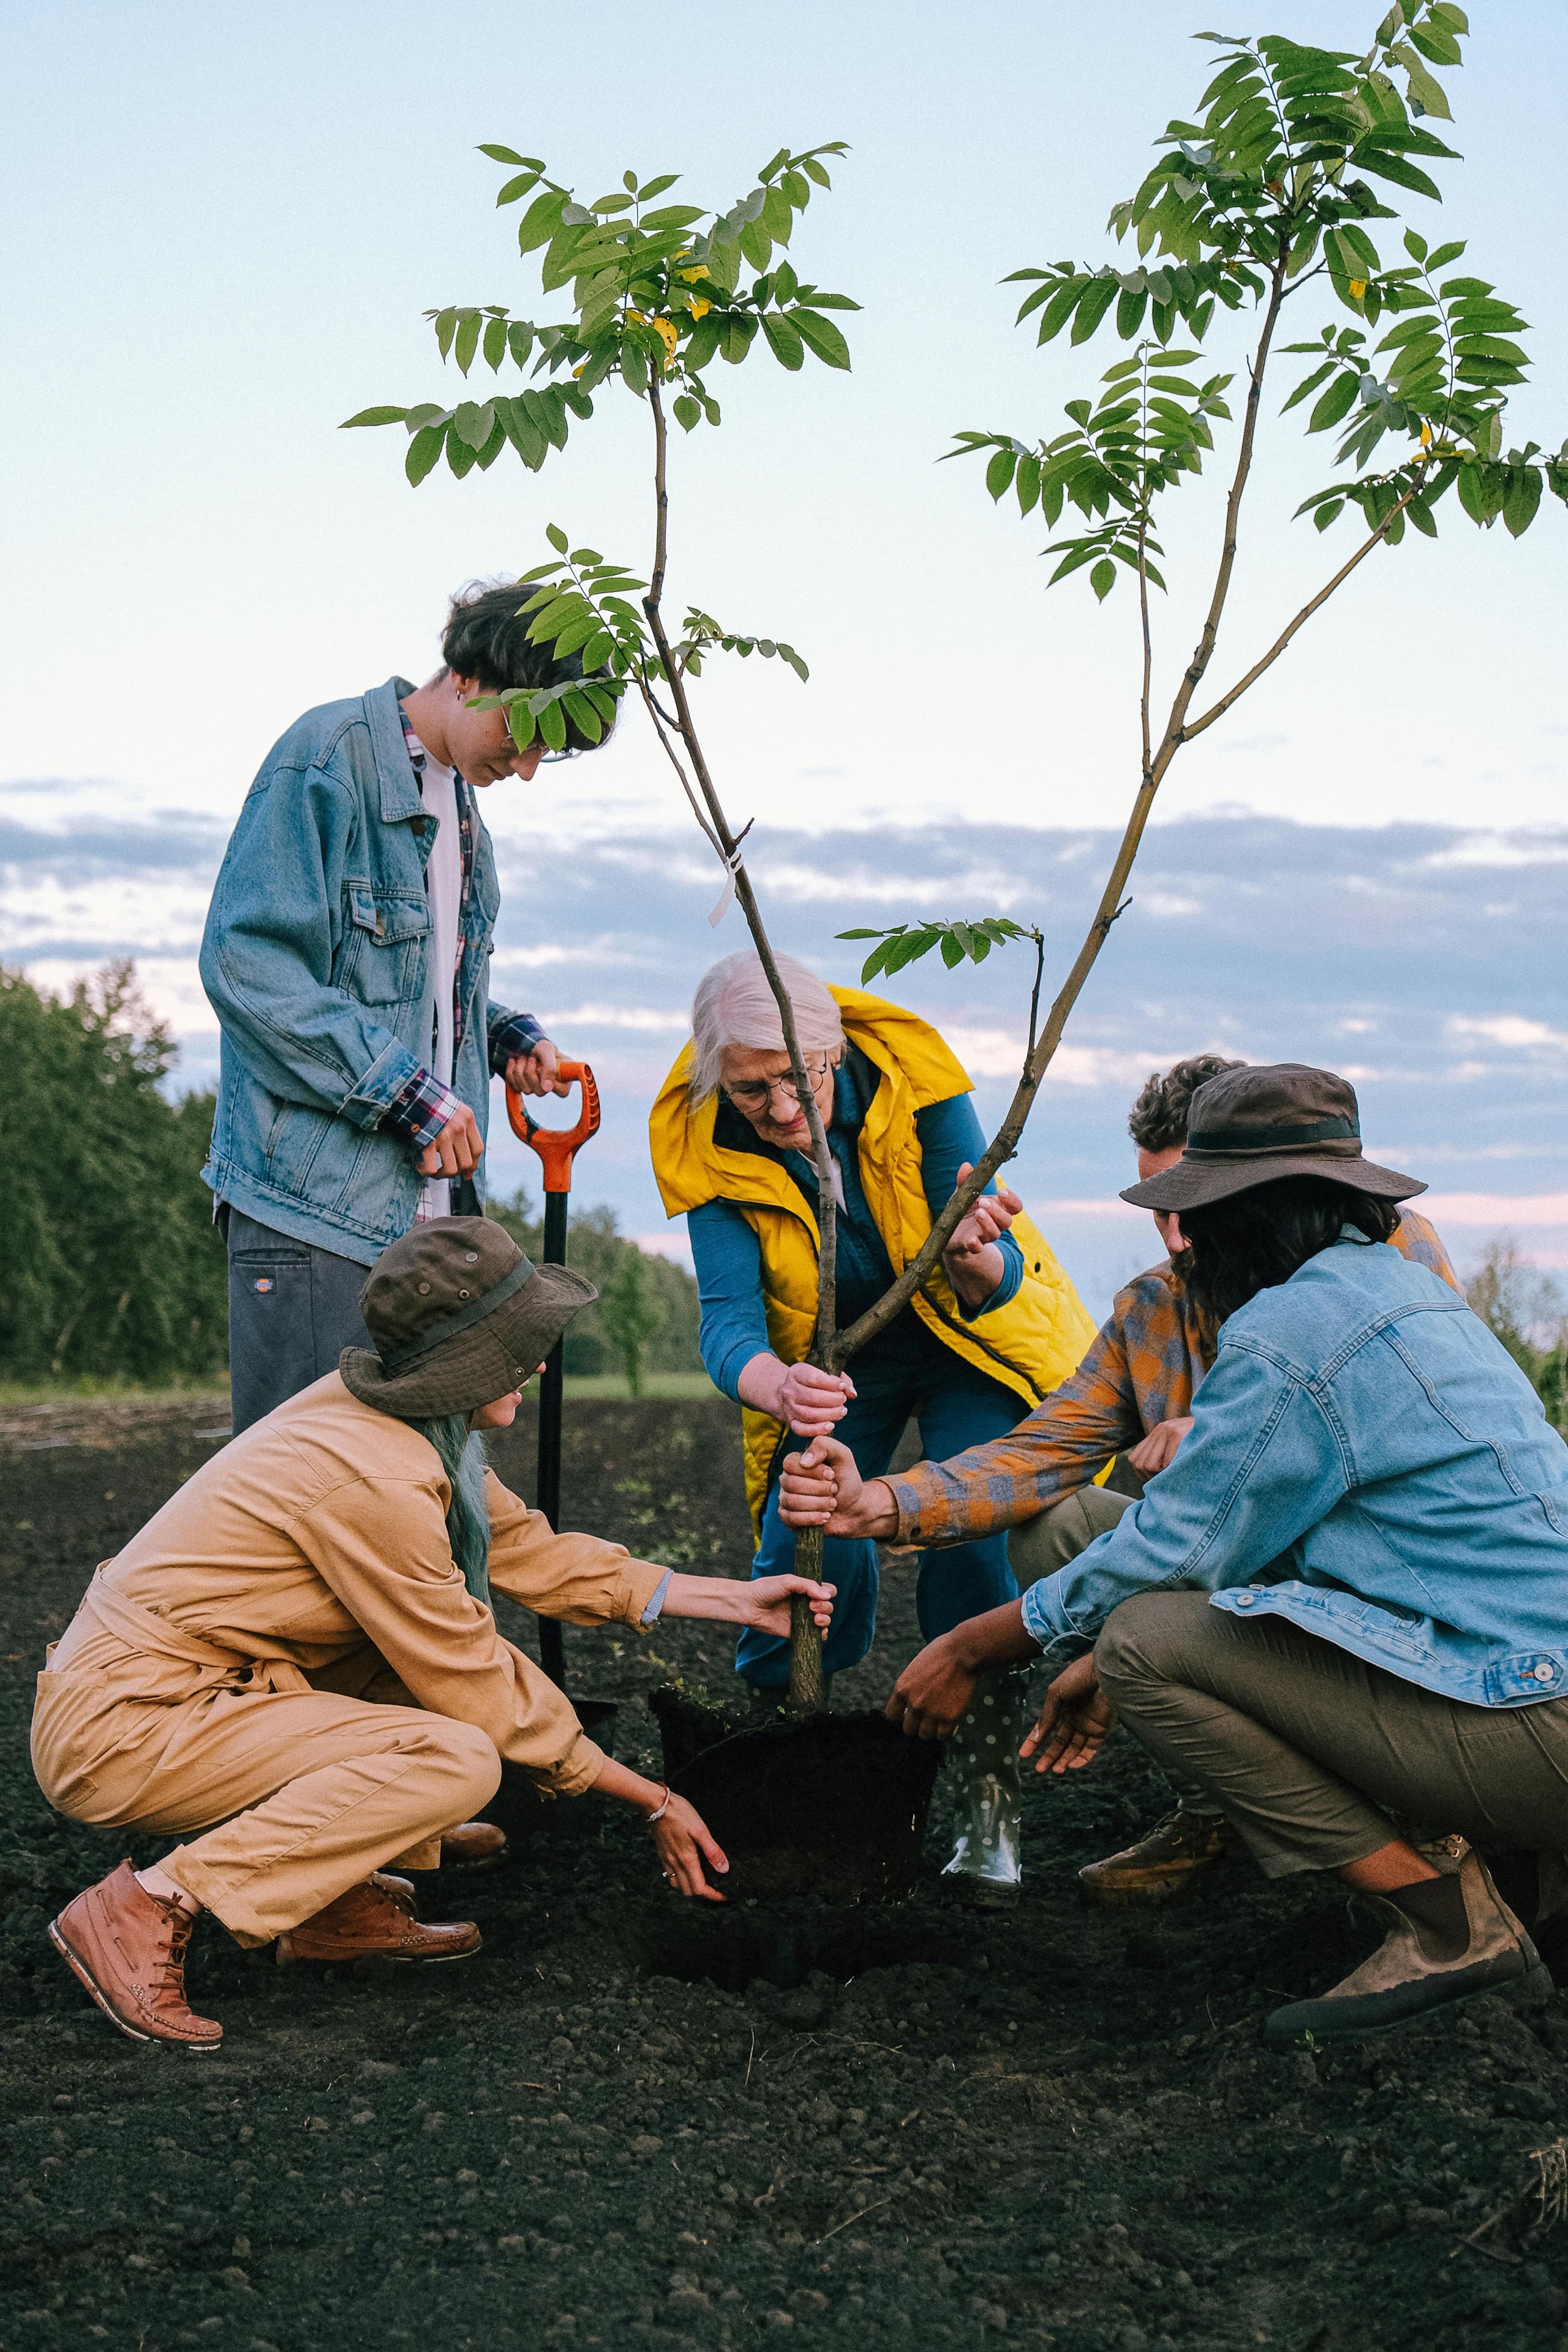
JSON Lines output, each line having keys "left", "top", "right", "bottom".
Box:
{"left": 339, "top": 1216, "right": 600, "bottom": 1420}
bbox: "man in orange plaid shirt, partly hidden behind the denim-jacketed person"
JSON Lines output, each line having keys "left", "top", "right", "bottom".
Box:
{"left": 780, "top": 1054, "right": 1460, "bottom": 1905}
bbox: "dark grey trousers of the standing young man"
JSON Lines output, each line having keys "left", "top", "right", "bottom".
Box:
{"left": 224, "top": 1207, "right": 374, "bottom": 1437}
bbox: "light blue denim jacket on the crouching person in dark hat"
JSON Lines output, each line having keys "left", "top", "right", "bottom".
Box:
{"left": 1023, "top": 1227, "right": 1568, "bottom": 1708}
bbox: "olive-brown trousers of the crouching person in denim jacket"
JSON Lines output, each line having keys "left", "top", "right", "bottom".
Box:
{"left": 1096, "top": 1593, "right": 1568, "bottom": 1879}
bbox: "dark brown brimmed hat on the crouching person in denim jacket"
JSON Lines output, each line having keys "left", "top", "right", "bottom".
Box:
{"left": 1121, "top": 1061, "right": 1427, "bottom": 1212}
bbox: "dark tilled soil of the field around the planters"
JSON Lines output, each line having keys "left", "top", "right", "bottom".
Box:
{"left": 0, "top": 1402, "right": 1568, "bottom": 2352}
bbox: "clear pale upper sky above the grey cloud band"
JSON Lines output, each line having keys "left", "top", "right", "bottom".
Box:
{"left": 12, "top": 0, "right": 1568, "bottom": 835}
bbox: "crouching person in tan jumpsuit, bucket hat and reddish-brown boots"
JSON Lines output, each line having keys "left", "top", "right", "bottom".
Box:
{"left": 33, "top": 1216, "right": 832, "bottom": 2049}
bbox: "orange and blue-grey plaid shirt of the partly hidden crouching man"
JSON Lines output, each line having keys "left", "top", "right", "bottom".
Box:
{"left": 886, "top": 1209, "right": 1460, "bottom": 1543}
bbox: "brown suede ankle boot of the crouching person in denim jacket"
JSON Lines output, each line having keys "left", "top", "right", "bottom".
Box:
{"left": 1262, "top": 1851, "right": 1545, "bottom": 2049}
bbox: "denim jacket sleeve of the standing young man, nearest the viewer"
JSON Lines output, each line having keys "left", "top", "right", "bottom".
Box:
{"left": 202, "top": 760, "right": 423, "bottom": 1126}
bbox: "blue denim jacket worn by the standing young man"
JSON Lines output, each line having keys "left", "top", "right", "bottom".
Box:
{"left": 202, "top": 677, "right": 538, "bottom": 1265}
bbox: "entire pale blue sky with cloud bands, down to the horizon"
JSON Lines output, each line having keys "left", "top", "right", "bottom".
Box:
{"left": 0, "top": 0, "right": 1568, "bottom": 1284}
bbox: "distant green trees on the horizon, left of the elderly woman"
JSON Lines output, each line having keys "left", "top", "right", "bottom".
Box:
{"left": 0, "top": 962, "right": 701, "bottom": 1385}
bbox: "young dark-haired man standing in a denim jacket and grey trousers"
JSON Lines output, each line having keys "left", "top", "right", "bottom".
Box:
{"left": 202, "top": 581, "right": 592, "bottom": 1433}
